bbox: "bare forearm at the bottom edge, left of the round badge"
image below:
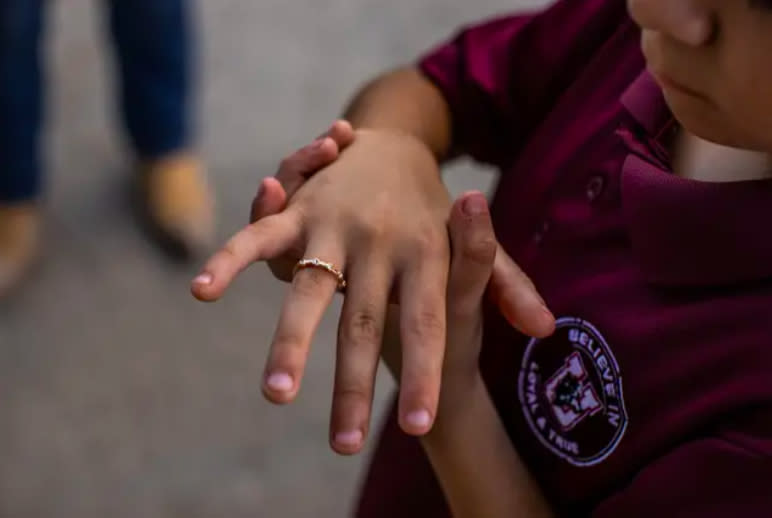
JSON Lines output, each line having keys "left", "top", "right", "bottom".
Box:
{"left": 422, "top": 376, "right": 552, "bottom": 518}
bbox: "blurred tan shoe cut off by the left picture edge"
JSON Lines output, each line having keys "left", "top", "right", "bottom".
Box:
{"left": 0, "top": 202, "right": 41, "bottom": 299}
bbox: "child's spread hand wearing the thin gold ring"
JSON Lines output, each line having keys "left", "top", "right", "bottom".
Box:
{"left": 193, "top": 122, "right": 554, "bottom": 453}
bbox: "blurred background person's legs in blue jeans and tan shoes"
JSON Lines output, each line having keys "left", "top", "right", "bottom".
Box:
{"left": 0, "top": 0, "right": 214, "bottom": 297}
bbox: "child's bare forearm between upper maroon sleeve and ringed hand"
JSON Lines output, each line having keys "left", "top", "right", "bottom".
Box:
{"left": 344, "top": 67, "right": 451, "bottom": 160}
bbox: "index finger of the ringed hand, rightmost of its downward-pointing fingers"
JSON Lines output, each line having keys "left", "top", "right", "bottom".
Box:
{"left": 399, "top": 234, "right": 449, "bottom": 435}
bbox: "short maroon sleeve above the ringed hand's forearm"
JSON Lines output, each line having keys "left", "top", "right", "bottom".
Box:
{"left": 419, "top": 0, "right": 629, "bottom": 166}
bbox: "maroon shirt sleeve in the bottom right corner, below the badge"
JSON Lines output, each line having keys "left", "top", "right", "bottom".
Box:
{"left": 592, "top": 438, "right": 772, "bottom": 518}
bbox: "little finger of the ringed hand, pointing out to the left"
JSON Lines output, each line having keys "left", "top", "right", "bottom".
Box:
{"left": 191, "top": 212, "right": 300, "bottom": 302}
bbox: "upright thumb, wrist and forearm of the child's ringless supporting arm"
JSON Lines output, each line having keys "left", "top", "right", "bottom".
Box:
{"left": 392, "top": 192, "right": 554, "bottom": 518}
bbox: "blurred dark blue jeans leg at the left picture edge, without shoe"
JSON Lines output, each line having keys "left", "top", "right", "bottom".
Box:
{"left": 0, "top": 0, "right": 45, "bottom": 203}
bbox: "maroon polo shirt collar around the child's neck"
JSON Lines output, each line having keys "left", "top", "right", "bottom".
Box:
{"left": 620, "top": 72, "right": 772, "bottom": 286}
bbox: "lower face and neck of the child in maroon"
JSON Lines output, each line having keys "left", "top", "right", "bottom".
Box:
{"left": 627, "top": 0, "right": 772, "bottom": 181}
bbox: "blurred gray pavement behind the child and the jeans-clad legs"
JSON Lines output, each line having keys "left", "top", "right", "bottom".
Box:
{"left": 0, "top": 0, "right": 543, "bottom": 518}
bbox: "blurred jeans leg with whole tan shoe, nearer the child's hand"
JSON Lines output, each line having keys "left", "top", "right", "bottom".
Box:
{"left": 108, "top": 0, "right": 214, "bottom": 257}
